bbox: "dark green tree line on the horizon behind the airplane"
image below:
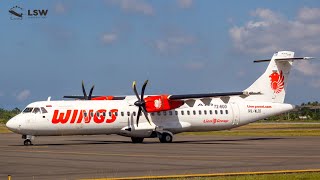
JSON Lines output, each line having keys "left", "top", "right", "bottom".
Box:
{"left": 0, "top": 101, "right": 320, "bottom": 124}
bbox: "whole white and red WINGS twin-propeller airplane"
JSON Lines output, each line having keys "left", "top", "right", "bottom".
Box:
{"left": 6, "top": 51, "right": 311, "bottom": 145}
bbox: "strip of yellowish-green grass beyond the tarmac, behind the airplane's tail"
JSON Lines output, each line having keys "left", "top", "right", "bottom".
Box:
{"left": 182, "top": 123, "right": 320, "bottom": 136}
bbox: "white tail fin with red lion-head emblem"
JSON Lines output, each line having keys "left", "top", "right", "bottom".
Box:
{"left": 244, "top": 51, "right": 294, "bottom": 103}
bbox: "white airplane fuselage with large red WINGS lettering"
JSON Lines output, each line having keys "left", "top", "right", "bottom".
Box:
{"left": 7, "top": 96, "right": 294, "bottom": 137}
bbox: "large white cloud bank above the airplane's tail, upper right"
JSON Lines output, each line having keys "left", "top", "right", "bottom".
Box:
{"left": 229, "top": 8, "right": 320, "bottom": 56}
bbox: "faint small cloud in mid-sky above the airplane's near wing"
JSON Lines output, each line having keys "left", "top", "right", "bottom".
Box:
{"left": 154, "top": 35, "right": 195, "bottom": 53}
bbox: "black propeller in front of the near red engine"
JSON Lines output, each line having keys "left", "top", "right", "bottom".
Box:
{"left": 132, "top": 80, "right": 151, "bottom": 127}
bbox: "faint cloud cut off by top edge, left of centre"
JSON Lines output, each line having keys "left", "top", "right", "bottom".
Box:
{"left": 109, "top": 0, "right": 155, "bottom": 15}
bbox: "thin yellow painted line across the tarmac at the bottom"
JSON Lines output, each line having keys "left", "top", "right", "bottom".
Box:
{"left": 82, "top": 169, "right": 320, "bottom": 180}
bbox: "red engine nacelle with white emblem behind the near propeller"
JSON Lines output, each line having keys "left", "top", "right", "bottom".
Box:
{"left": 144, "top": 95, "right": 184, "bottom": 112}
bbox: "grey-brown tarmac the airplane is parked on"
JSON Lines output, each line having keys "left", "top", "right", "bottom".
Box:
{"left": 0, "top": 134, "right": 320, "bottom": 180}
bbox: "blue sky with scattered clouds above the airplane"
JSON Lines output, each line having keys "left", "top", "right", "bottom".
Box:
{"left": 0, "top": 0, "right": 320, "bottom": 109}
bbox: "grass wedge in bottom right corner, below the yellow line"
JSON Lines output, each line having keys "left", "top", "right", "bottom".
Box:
{"left": 171, "top": 172, "right": 320, "bottom": 180}
